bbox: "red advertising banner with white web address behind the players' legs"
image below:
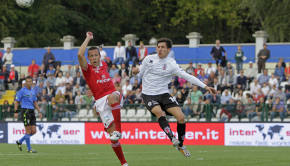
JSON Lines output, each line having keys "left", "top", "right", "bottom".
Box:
{"left": 85, "top": 123, "right": 224, "bottom": 145}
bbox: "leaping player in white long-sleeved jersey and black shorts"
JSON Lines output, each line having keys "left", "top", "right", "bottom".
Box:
{"left": 133, "top": 38, "right": 215, "bottom": 157}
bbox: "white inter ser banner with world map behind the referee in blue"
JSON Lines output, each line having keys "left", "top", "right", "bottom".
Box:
{"left": 8, "top": 123, "right": 85, "bottom": 144}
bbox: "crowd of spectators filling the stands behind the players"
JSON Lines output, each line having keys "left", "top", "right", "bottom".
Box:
{"left": 0, "top": 41, "right": 290, "bottom": 121}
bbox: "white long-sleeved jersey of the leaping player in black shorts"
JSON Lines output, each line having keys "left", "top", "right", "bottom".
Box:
{"left": 139, "top": 54, "right": 206, "bottom": 95}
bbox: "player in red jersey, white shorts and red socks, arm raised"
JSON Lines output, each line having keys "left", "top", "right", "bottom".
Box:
{"left": 78, "top": 32, "right": 128, "bottom": 166}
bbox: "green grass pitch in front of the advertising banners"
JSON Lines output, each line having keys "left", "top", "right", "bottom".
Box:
{"left": 0, "top": 144, "right": 290, "bottom": 166}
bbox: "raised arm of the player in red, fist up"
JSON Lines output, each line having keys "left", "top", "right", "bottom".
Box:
{"left": 78, "top": 32, "right": 93, "bottom": 70}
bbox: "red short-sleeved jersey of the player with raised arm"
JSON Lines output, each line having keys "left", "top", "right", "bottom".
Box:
{"left": 82, "top": 61, "right": 116, "bottom": 100}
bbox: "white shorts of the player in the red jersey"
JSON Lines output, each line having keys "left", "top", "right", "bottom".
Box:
{"left": 94, "top": 91, "right": 122, "bottom": 129}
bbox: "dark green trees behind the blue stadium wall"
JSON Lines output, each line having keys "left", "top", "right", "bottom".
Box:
{"left": 0, "top": 0, "right": 290, "bottom": 47}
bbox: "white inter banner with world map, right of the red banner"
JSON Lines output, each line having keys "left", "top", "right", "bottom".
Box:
{"left": 225, "top": 123, "right": 290, "bottom": 146}
